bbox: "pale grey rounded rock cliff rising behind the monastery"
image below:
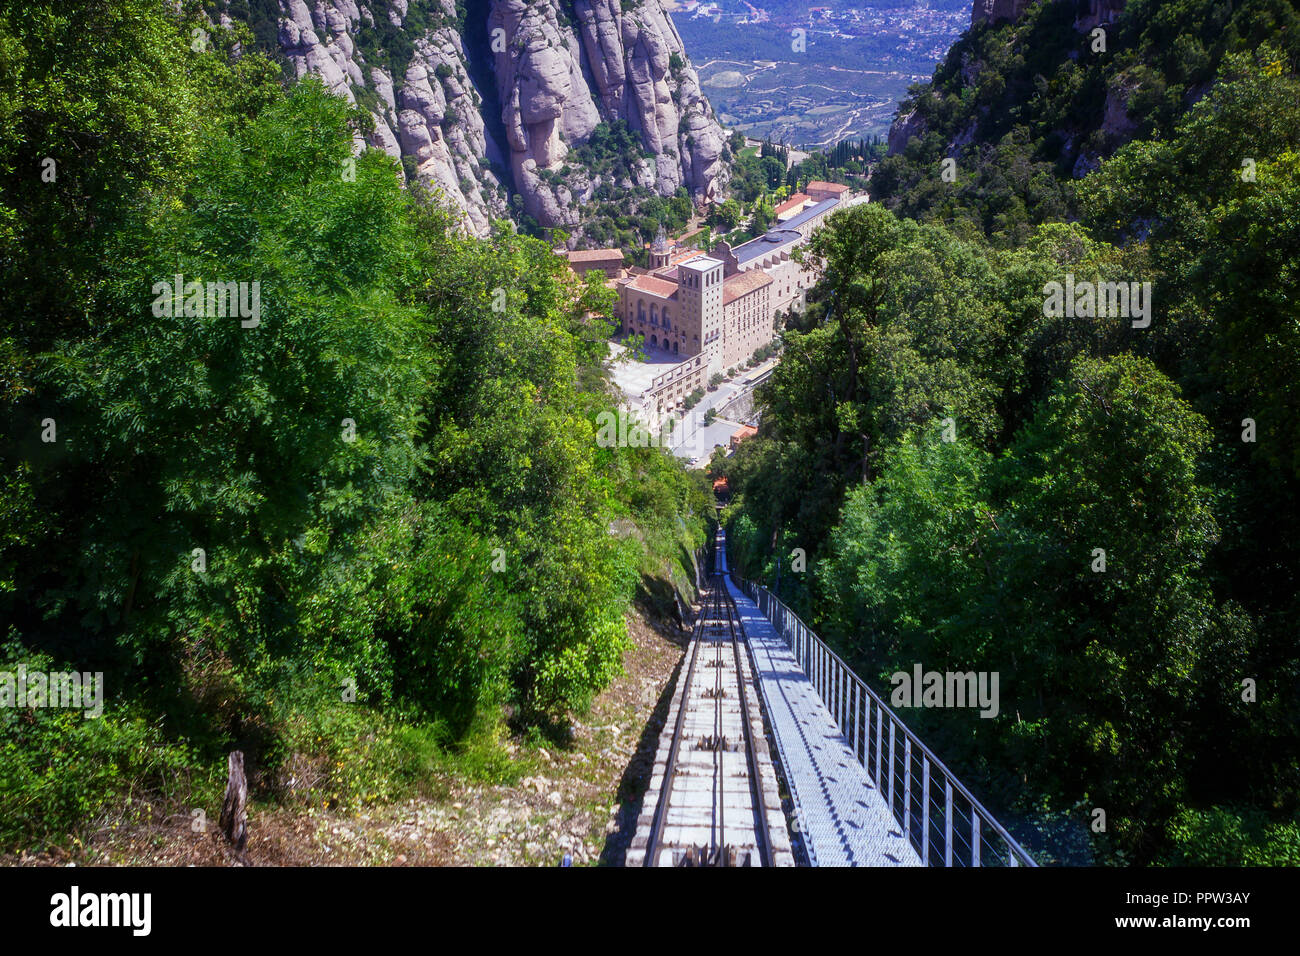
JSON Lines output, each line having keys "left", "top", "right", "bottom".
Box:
{"left": 229, "top": 0, "right": 727, "bottom": 234}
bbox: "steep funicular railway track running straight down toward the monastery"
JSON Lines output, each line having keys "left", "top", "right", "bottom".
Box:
{"left": 628, "top": 535, "right": 793, "bottom": 866}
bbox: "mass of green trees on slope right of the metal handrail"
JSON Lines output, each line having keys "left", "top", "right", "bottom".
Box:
{"left": 714, "top": 37, "right": 1300, "bottom": 865}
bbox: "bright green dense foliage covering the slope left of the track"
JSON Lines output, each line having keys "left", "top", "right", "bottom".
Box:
{"left": 0, "top": 0, "right": 706, "bottom": 847}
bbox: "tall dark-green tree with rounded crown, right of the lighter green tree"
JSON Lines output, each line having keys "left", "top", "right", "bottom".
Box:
{"left": 987, "top": 356, "right": 1249, "bottom": 853}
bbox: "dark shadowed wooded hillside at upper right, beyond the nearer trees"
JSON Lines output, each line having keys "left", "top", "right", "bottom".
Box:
{"left": 872, "top": 0, "right": 1300, "bottom": 245}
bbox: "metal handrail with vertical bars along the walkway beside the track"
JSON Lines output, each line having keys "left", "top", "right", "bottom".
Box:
{"left": 733, "top": 575, "right": 1037, "bottom": 866}
